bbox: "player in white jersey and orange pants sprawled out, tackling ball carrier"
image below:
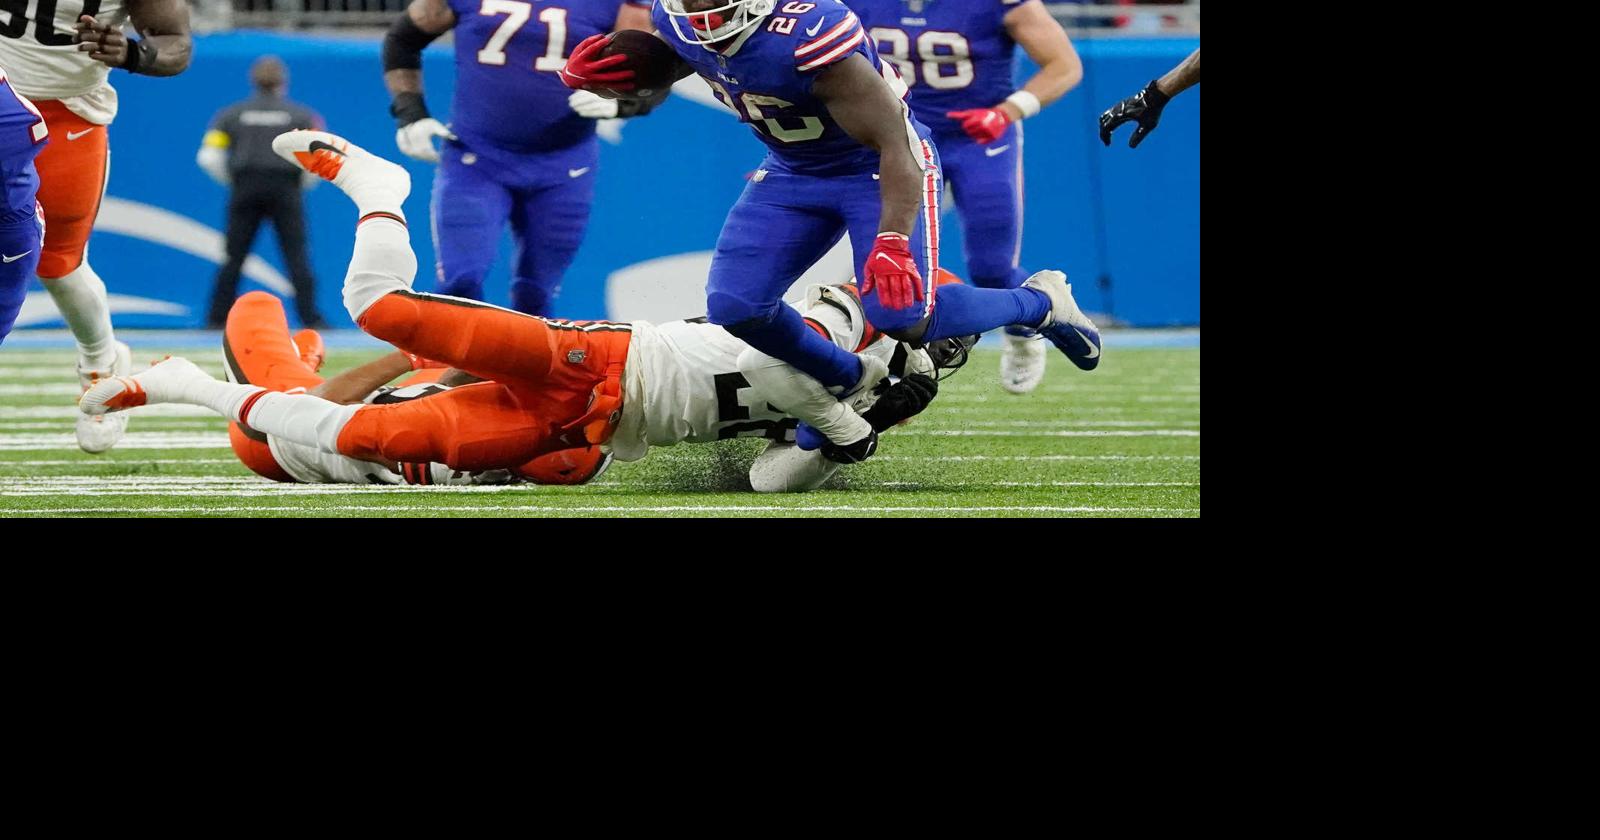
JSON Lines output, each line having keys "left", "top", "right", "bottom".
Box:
{"left": 80, "top": 131, "right": 985, "bottom": 490}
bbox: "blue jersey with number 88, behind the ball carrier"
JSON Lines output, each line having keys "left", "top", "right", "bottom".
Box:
{"left": 850, "top": 0, "right": 1037, "bottom": 138}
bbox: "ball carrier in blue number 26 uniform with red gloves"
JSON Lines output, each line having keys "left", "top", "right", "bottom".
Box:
{"left": 562, "top": 0, "right": 1101, "bottom": 458}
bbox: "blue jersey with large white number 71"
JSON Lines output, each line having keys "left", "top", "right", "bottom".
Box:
{"left": 450, "top": 0, "right": 645, "bottom": 152}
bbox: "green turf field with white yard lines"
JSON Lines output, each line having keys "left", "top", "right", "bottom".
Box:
{"left": 0, "top": 342, "right": 1200, "bottom": 518}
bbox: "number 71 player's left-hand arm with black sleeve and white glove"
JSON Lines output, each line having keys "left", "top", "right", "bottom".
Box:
{"left": 384, "top": 0, "right": 456, "bottom": 163}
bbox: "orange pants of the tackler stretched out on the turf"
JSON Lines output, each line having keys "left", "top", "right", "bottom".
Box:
{"left": 339, "top": 293, "right": 632, "bottom": 470}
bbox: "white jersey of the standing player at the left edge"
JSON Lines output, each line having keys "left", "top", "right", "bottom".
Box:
{"left": 0, "top": 0, "right": 128, "bottom": 125}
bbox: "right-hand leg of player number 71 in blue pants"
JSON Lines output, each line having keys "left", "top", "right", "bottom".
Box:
{"left": 510, "top": 166, "right": 595, "bottom": 315}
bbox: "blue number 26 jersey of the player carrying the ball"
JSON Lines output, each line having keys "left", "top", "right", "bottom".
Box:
{"left": 651, "top": 0, "right": 906, "bottom": 176}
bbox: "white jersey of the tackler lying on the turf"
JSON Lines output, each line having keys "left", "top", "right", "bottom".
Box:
{"left": 610, "top": 286, "right": 894, "bottom": 461}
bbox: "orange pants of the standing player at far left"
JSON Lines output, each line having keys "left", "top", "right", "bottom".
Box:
{"left": 34, "top": 99, "right": 110, "bottom": 280}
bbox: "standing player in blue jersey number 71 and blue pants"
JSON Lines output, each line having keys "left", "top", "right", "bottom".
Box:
{"left": 384, "top": 0, "right": 650, "bottom": 315}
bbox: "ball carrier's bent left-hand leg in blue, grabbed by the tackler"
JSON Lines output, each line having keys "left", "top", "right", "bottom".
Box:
{"left": 706, "top": 173, "right": 862, "bottom": 389}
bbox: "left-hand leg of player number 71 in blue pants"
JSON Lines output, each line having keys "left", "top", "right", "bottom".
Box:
{"left": 430, "top": 142, "right": 512, "bottom": 301}
